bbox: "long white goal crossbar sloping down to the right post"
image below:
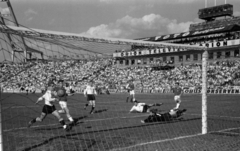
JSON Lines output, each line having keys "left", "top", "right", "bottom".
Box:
{"left": 0, "top": 25, "right": 206, "bottom": 51}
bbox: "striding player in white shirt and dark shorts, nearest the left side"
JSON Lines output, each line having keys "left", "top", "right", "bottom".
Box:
{"left": 28, "top": 86, "right": 71, "bottom": 131}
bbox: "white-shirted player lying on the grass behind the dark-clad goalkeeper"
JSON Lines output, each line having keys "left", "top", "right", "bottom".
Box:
{"left": 129, "top": 100, "right": 162, "bottom": 113}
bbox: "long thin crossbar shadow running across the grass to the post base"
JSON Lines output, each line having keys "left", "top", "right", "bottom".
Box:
{"left": 23, "top": 118, "right": 201, "bottom": 151}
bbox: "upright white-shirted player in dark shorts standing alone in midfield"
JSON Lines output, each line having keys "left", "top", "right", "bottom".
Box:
{"left": 83, "top": 81, "right": 97, "bottom": 114}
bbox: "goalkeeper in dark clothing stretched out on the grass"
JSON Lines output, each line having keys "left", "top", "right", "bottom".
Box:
{"left": 141, "top": 109, "right": 187, "bottom": 123}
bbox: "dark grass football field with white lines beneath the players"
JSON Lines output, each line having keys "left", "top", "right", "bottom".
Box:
{"left": 1, "top": 93, "right": 240, "bottom": 151}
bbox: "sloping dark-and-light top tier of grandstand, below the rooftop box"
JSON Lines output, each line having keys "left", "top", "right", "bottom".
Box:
{"left": 136, "top": 24, "right": 240, "bottom": 41}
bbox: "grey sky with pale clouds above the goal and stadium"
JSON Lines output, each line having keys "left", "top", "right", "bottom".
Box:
{"left": 0, "top": 0, "right": 240, "bottom": 39}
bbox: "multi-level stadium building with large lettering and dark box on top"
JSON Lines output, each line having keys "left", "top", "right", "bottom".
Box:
{"left": 113, "top": 4, "right": 240, "bottom": 67}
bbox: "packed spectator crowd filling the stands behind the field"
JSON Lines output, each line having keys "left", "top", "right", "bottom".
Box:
{"left": 0, "top": 59, "right": 240, "bottom": 91}
